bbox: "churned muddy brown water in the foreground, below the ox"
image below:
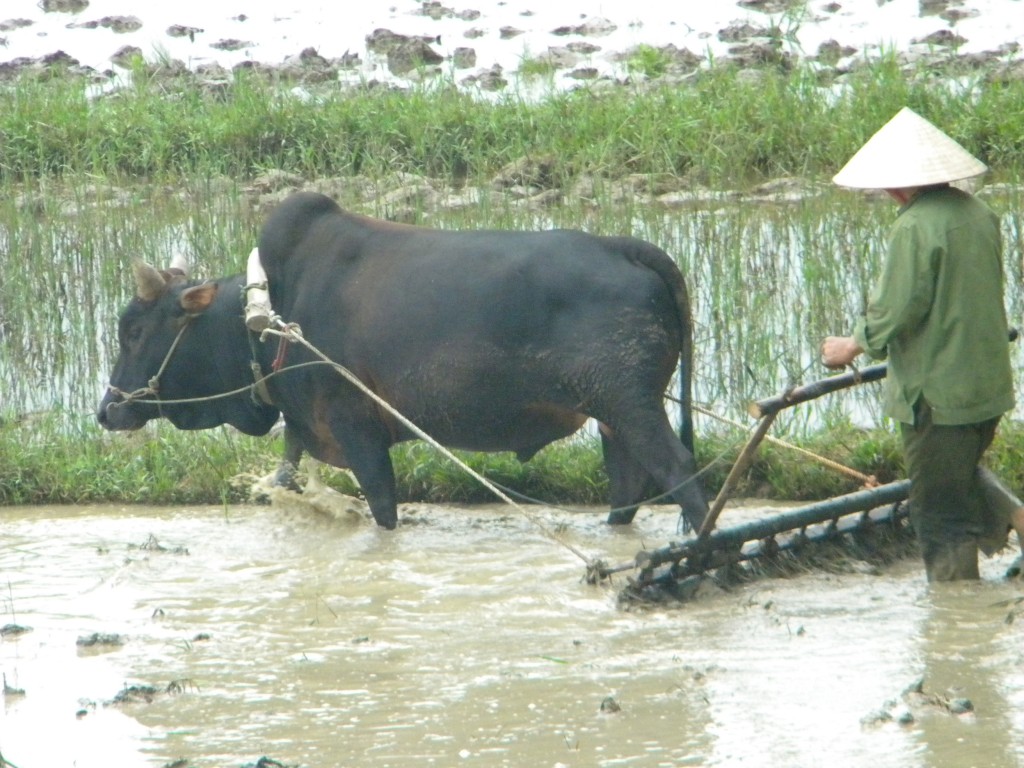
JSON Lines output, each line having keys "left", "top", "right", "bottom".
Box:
{"left": 0, "top": 501, "right": 1024, "bottom": 768}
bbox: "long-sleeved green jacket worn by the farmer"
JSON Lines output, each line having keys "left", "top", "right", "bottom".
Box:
{"left": 853, "top": 186, "right": 1014, "bottom": 424}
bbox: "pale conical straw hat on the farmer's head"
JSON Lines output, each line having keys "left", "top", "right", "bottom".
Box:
{"left": 833, "top": 106, "right": 988, "bottom": 189}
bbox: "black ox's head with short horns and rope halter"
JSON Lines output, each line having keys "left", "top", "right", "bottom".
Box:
{"left": 97, "top": 261, "right": 278, "bottom": 434}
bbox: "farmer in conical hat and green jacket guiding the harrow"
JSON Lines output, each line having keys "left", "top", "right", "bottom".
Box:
{"left": 821, "top": 108, "right": 1024, "bottom": 582}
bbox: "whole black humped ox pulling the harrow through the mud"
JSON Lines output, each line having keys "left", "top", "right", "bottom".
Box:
{"left": 98, "top": 193, "right": 708, "bottom": 528}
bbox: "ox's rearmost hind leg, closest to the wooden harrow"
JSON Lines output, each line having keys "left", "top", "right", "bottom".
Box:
{"left": 609, "top": 411, "right": 708, "bottom": 529}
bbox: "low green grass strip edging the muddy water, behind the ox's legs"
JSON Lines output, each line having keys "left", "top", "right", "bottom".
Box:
{"left": 0, "top": 405, "right": 966, "bottom": 506}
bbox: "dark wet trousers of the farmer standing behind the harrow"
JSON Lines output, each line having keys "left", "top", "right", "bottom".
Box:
{"left": 901, "top": 400, "right": 999, "bottom": 582}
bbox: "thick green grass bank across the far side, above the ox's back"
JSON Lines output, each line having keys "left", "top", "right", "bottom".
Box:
{"left": 0, "top": 54, "right": 1024, "bottom": 186}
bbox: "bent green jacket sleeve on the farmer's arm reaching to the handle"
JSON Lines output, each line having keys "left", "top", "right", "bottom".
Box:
{"left": 853, "top": 225, "right": 936, "bottom": 359}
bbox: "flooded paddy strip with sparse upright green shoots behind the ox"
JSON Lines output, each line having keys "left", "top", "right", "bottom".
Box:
{"left": 0, "top": 185, "right": 1024, "bottom": 432}
